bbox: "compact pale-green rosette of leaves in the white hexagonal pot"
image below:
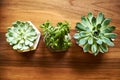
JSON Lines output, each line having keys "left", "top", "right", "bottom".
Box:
{"left": 6, "top": 21, "right": 37, "bottom": 51}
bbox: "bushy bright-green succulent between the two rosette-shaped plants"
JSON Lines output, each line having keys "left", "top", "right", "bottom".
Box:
{"left": 40, "top": 21, "right": 71, "bottom": 52}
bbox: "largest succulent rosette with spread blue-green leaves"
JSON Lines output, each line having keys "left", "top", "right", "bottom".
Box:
{"left": 74, "top": 13, "right": 116, "bottom": 55}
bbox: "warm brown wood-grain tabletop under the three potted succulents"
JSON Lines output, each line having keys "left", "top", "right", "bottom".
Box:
{"left": 0, "top": 0, "right": 120, "bottom": 80}
